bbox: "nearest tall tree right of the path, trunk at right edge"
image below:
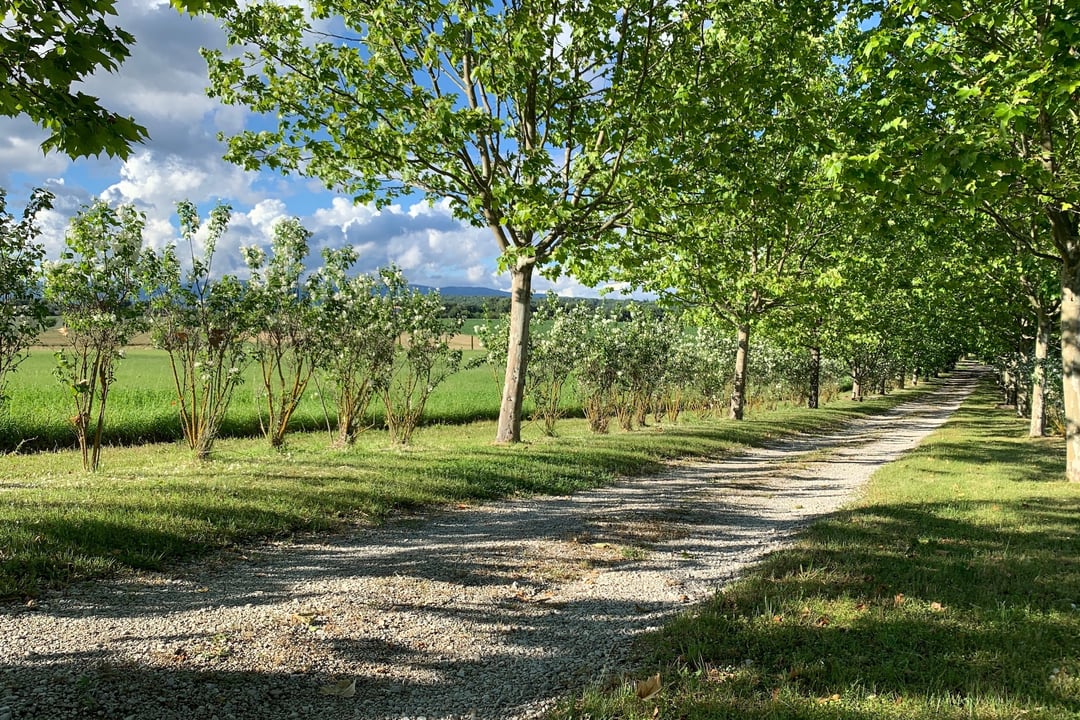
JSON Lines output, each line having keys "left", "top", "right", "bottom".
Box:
{"left": 849, "top": 0, "right": 1080, "bottom": 481}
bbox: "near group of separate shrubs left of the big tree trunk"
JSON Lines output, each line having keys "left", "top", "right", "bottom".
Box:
{"left": 0, "top": 193, "right": 461, "bottom": 471}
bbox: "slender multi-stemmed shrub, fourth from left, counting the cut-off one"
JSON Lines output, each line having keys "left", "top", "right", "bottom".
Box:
{"left": 244, "top": 218, "right": 326, "bottom": 447}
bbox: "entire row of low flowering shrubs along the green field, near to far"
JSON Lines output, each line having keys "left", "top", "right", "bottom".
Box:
{"left": 0, "top": 188, "right": 972, "bottom": 470}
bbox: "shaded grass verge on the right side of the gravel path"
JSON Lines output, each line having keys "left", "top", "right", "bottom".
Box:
{"left": 554, "top": 379, "right": 1080, "bottom": 720}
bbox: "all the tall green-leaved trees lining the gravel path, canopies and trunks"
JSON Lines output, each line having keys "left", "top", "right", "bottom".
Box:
{"left": 4, "top": 0, "right": 1080, "bottom": 480}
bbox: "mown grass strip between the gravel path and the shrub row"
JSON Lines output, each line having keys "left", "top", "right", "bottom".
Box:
{"left": 0, "top": 379, "right": 928, "bottom": 598}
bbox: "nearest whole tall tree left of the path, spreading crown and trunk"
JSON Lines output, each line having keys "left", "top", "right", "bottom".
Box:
{"left": 189, "top": 0, "right": 693, "bottom": 441}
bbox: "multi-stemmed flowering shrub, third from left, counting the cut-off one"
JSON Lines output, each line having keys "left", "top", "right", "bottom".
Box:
{"left": 149, "top": 202, "right": 252, "bottom": 458}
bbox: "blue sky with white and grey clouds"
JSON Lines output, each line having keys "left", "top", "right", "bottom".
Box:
{"left": 0, "top": 0, "right": 617, "bottom": 297}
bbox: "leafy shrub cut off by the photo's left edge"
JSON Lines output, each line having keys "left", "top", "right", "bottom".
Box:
{"left": 0, "top": 185, "right": 52, "bottom": 411}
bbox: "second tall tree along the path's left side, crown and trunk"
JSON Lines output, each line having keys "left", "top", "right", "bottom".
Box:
{"left": 585, "top": 2, "right": 838, "bottom": 419}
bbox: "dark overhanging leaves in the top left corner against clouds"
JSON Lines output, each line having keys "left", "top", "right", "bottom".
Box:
{"left": 0, "top": 0, "right": 149, "bottom": 159}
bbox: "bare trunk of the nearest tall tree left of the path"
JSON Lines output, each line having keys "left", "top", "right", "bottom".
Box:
{"left": 495, "top": 258, "right": 536, "bottom": 443}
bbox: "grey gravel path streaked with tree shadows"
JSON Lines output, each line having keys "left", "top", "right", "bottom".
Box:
{"left": 0, "top": 369, "right": 978, "bottom": 720}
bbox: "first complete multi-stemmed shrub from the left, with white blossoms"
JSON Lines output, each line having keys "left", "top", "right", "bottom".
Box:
{"left": 44, "top": 202, "right": 152, "bottom": 471}
